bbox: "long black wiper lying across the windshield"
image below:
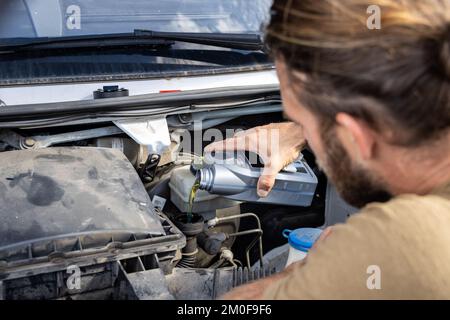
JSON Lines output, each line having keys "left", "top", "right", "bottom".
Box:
{"left": 0, "top": 29, "right": 263, "bottom": 53}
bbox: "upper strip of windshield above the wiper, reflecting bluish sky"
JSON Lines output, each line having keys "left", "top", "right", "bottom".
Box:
{"left": 0, "top": 0, "right": 271, "bottom": 38}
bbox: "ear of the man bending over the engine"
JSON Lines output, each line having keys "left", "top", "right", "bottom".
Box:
{"left": 336, "top": 112, "right": 376, "bottom": 160}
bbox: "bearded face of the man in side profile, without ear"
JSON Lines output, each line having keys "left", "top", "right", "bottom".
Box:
{"left": 276, "top": 62, "right": 391, "bottom": 208}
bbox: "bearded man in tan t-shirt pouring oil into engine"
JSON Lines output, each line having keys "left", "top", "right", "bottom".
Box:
{"left": 207, "top": 0, "right": 450, "bottom": 299}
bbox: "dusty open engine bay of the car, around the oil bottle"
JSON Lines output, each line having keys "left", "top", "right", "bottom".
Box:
{"left": 0, "top": 112, "right": 336, "bottom": 299}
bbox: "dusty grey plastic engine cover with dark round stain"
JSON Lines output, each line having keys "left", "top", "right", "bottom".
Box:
{"left": 0, "top": 147, "right": 164, "bottom": 250}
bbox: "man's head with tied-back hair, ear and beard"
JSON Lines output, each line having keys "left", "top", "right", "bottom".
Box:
{"left": 266, "top": 0, "right": 450, "bottom": 207}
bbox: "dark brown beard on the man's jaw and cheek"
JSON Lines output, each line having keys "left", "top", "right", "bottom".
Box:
{"left": 317, "top": 128, "right": 392, "bottom": 208}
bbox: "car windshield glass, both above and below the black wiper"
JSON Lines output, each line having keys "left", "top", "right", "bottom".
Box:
{"left": 0, "top": 0, "right": 273, "bottom": 86}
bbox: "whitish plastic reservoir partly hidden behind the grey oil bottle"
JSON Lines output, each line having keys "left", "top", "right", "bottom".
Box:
{"left": 169, "top": 165, "right": 240, "bottom": 214}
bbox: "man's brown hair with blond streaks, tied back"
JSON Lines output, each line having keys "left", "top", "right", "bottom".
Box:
{"left": 266, "top": 0, "right": 450, "bottom": 146}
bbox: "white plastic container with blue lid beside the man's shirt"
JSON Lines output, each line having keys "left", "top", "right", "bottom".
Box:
{"left": 283, "top": 228, "right": 322, "bottom": 267}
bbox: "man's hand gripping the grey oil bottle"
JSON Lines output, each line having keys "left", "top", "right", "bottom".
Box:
{"left": 205, "top": 122, "right": 306, "bottom": 197}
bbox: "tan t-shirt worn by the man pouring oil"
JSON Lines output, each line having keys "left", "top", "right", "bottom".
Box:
{"left": 264, "top": 184, "right": 450, "bottom": 299}
